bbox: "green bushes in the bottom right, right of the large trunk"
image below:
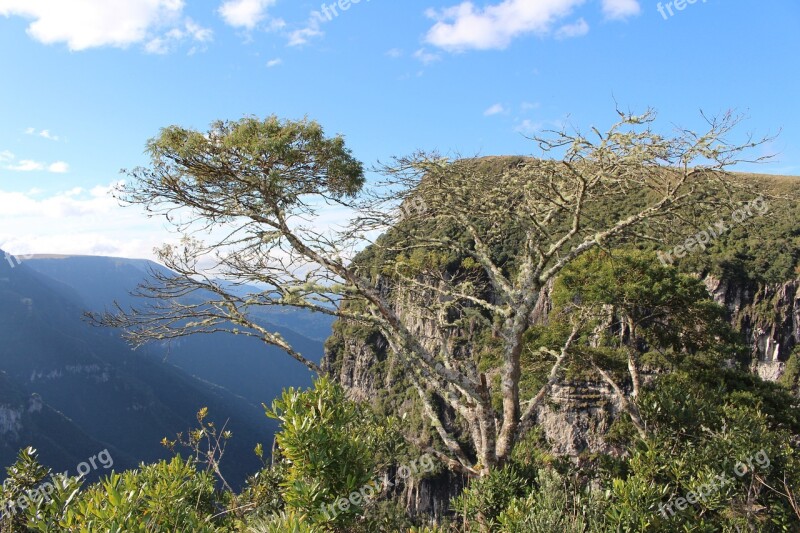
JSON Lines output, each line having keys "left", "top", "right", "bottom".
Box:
{"left": 452, "top": 357, "right": 800, "bottom": 533}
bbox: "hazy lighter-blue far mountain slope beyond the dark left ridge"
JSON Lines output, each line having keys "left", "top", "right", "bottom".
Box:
{"left": 24, "top": 256, "right": 333, "bottom": 416}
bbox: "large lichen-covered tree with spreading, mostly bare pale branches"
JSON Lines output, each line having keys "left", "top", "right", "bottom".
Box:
{"left": 94, "top": 111, "right": 776, "bottom": 475}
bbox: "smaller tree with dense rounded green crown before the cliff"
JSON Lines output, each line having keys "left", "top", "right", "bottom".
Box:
{"left": 553, "top": 250, "right": 746, "bottom": 438}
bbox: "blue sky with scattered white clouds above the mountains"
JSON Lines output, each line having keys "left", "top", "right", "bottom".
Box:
{"left": 0, "top": 0, "right": 800, "bottom": 257}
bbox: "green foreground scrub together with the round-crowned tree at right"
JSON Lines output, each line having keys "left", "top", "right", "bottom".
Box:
{"left": 0, "top": 252, "right": 800, "bottom": 532}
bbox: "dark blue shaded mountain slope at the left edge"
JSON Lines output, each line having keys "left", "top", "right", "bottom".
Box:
{"left": 0, "top": 251, "right": 288, "bottom": 485}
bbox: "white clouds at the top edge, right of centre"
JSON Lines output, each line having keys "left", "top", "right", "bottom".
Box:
{"left": 425, "top": 0, "right": 641, "bottom": 52}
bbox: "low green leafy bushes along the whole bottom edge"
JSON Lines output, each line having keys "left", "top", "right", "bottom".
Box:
{"left": 2, "top": 360, "right": 800, "bottom": 533}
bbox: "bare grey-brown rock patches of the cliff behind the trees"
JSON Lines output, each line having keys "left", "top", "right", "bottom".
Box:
{"left": 323, "top": 276, "right": 800, "bottom": 516}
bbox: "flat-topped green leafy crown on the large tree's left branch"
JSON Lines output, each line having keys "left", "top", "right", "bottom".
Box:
{"left": 144, "top": 116, "right": 364, "bottom": 210}
